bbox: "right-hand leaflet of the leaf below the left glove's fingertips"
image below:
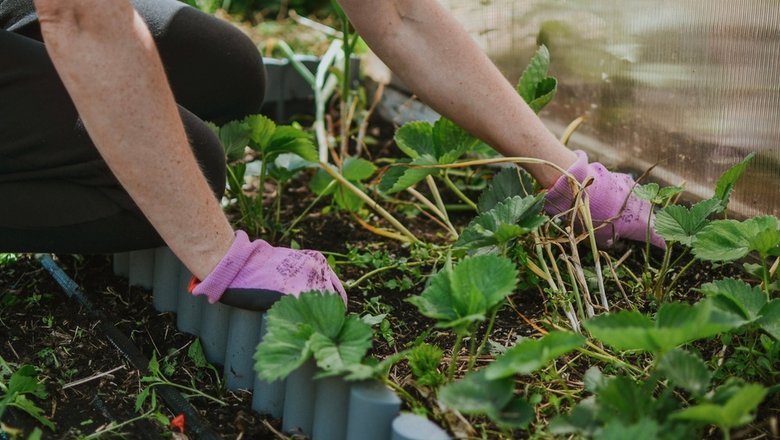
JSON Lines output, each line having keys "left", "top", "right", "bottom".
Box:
{"left": 310, "top": 314, "right": 374, "bottom": 374}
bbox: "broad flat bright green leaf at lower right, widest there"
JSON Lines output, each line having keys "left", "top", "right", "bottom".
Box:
{"left": 585, "top": 301, "right": 744, "bottom": 353}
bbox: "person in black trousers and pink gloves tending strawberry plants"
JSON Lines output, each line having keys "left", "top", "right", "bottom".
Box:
{"left": 0, "top": 0, "right": 663, "bottom": 303}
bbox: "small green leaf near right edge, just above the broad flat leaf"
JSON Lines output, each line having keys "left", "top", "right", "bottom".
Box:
{"left": 698, "top": 278, "right": 766, "bottom": 322}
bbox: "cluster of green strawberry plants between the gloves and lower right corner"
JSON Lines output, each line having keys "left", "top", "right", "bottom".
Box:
{"left": 245, "top": 42, "right": 780, "bottom": 439}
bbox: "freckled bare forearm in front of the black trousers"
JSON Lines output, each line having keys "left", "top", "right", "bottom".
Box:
{"left": 35, "top": 0, "right": 233, "bottom": 279}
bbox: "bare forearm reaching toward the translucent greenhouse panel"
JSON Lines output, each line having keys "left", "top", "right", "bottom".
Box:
{"left": 340, "top": 0, "right": 576, "bottom": 187}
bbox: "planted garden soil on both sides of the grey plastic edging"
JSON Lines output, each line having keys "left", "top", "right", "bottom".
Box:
{"left": 0, "top": 7, "right": 780, "bottom": 440}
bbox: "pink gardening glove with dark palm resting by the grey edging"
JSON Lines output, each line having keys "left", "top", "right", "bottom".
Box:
{"left": 190, "top": 231, "right": 347, "bottom": 310}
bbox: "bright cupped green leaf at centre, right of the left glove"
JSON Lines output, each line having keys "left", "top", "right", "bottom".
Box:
{"left": 409, "top": 255, "right": 517, "bottom": 329}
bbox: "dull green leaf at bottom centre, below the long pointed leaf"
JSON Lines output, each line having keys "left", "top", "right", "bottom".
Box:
{"left": 439, "top": 370, "right": 514, "bottom": 414}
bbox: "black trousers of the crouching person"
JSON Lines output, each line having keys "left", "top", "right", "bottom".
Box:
{"left": 0, "top": 0, "right": 265, "bottom": 253}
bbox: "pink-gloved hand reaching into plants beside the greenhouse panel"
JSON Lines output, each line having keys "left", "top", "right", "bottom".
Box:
{"left": 545, "top": 151, "right": 666, "bottom": 249}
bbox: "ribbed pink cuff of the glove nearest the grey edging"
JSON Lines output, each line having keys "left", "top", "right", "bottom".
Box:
{"left": 191, "top": 231, "right": 265, "bottom": 304}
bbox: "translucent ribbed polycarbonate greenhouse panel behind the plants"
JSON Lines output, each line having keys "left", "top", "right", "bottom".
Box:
{"left": 442, "top": 0, "right": 780, "bottom": 216}
